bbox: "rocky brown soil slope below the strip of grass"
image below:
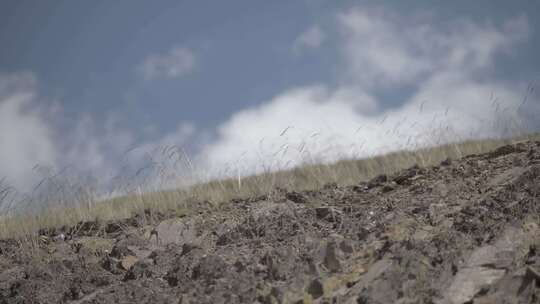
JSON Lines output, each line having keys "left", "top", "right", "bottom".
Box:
{"left": 0, "top": 142, "right": 540, "bottom": 304}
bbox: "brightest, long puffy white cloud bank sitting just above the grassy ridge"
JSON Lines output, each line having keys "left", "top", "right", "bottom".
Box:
{"left": 198, "top": 81, "right": 519, "bottom": 175}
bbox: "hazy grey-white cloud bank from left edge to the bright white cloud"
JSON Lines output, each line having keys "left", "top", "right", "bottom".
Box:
{"left": 0, "top": 73, "right": 201, "bottom": 201}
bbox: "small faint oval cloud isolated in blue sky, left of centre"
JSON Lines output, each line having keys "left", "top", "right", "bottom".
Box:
{"left": 138, "top": 46, "right": 196, "bottom": 80}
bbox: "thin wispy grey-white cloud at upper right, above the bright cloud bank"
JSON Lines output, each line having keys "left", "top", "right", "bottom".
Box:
{"left": 338, "top": 9, "right": 527, "bottom": 87}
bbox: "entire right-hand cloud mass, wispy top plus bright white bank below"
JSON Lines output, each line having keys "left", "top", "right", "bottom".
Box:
{"left": 198, "top": 8, "right": 532, "bottom": 174}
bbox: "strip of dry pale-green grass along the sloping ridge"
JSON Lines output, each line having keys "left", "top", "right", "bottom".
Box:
{"left": 0, "top": 134, "right": 540, "bottom": 239}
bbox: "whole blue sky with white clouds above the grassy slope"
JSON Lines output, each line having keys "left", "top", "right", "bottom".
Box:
{"left": 0, "top": 0, "right": 540, "bottom": 204}
